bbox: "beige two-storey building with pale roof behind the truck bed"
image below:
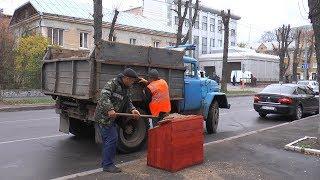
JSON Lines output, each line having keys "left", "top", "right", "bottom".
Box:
{"left": 10, "top": 0, "right": 175, "bottom": 50}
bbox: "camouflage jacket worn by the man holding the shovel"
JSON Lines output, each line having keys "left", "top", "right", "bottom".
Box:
{"left": 95, "top": 74, "right": 135, "bottom": 126}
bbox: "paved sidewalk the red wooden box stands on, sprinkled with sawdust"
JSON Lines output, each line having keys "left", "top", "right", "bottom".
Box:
{"left": 65, "top": 116, "right": 320, "bottom": 180}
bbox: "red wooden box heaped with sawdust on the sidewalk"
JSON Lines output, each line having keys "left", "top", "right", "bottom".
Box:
{"left": 147, "top": 115, "right": 204, "bottom": 172}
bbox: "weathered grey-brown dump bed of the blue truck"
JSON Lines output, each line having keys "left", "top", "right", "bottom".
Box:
{"left": 42, "top": 41, "right": 185, "bottom": 101}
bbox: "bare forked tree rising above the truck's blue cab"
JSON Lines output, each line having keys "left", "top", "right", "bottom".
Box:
{"left": 172, "top": 0, "right": 199, "bottom": 46}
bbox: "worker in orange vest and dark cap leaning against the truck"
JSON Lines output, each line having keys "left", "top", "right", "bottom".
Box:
{"left": 140, "top": 69, "right": 171, "bottom": 119}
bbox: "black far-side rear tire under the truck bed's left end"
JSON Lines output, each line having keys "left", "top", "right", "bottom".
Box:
{"left": 69, "top": 118, "right": 94, "bottom": 138}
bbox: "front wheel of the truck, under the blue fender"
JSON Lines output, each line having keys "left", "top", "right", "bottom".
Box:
{"left": 206, "top": 101, "right": 219, "bottom": 134}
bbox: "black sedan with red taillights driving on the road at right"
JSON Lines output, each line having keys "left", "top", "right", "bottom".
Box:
{"left": 254, "top": 84, "right": 319, "bottom": 119}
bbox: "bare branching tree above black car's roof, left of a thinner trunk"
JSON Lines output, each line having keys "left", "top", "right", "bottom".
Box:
{"left": 273, "top": 24, "right": 293, "bottom": 83}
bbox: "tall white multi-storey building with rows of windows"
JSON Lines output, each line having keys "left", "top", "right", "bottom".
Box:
{"left": 131, "top": 0, "right": 240, "bottom": 57}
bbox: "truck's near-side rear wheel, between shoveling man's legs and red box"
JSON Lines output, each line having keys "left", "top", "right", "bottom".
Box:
{"left": 117, "top": 109, "right": 148, "bottom": 153}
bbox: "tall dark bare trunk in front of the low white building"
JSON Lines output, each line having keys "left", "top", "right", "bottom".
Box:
{"left": 221, "top": 9, "right": 231, "bottom": 92}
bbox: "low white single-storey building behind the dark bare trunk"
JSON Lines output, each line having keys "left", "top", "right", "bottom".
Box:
{"left": 199, "top": 47, "right": 279, "bottom": 82}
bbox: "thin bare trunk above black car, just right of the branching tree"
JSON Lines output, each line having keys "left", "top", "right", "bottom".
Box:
{"left": 292, "top": 29, "right": 302, "bottom": 82}
